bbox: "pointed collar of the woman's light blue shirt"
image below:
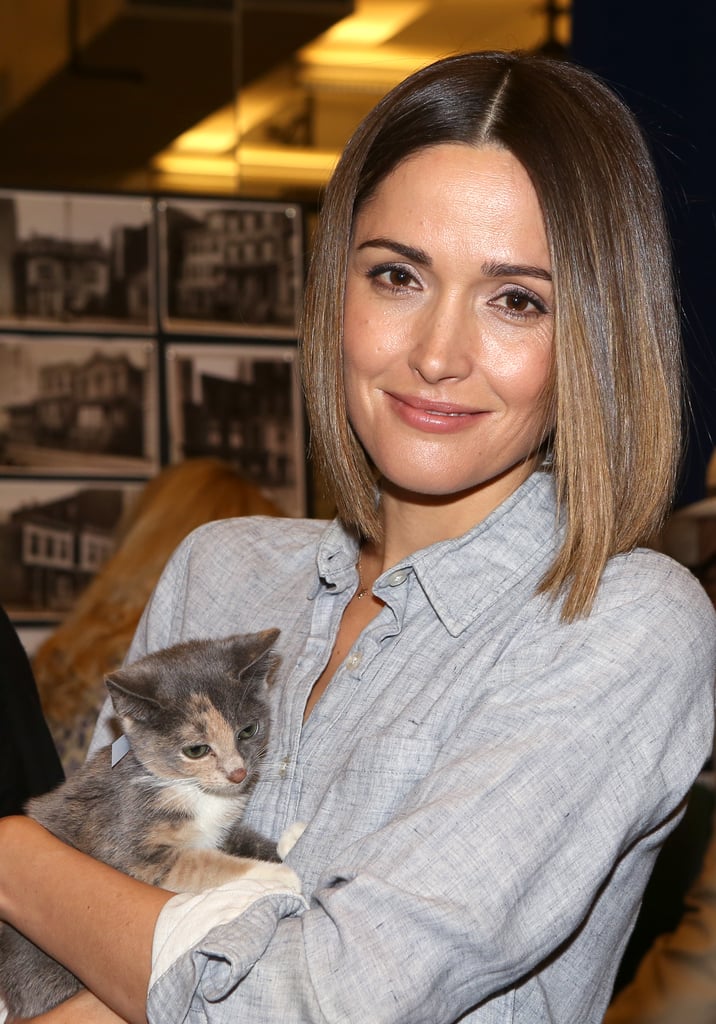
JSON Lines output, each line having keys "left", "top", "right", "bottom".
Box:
{"left": 318, "top": 470, "right": 561, "bottom": 636}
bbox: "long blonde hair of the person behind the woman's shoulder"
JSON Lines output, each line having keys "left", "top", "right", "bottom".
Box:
{"left": 33, "top": 459, "right": 282, "bottom": 771}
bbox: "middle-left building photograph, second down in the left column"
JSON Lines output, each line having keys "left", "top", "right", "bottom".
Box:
{"left": 0, "top": 334, "right": 160, "bottom": 477}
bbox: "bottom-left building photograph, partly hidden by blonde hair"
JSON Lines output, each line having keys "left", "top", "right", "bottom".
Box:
{"left": 0, "top": 479, "right": 142, "bottom": 622}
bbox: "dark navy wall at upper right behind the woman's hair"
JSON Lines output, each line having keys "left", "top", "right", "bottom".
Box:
{"left": 572, "top": 0, "right": 716, "bottom": 504}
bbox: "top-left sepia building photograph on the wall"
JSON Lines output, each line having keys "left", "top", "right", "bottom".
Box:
{"left": 0, "top": 190, "right": 157, "bottom": 334}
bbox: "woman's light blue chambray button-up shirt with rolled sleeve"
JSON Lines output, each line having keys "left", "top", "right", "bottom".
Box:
{"left": 95, "top": 472, "right": 716, "bottom": 1024}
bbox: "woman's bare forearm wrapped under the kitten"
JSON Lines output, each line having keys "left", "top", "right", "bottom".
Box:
{"left": 0, "top": 817, "right": 172, "bottom": 1024}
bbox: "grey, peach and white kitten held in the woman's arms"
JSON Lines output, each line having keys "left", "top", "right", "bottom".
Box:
{"left": 0, "top": 630, "right": 297, "bottom": 1017}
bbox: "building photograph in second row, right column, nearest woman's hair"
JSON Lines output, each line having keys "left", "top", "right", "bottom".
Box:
{"left": 166, "top": 343, "right": 306, "bottom": 516}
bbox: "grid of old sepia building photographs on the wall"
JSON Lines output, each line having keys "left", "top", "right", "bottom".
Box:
{"left": 0, "top": 190, "right": 307, "bottom": 632}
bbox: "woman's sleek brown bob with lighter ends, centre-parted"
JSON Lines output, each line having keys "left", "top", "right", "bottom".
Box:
{"left": 302, "top": 52, "right": 682, "bottom": 620}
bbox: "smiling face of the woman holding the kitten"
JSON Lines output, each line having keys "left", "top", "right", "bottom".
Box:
{"left": 343, "top": 143, "right": 553, "bottom": 514}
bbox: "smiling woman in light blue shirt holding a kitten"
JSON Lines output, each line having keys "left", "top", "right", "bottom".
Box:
{"left": 0, "top": 53, "right": 716, "bottom": 1024}
